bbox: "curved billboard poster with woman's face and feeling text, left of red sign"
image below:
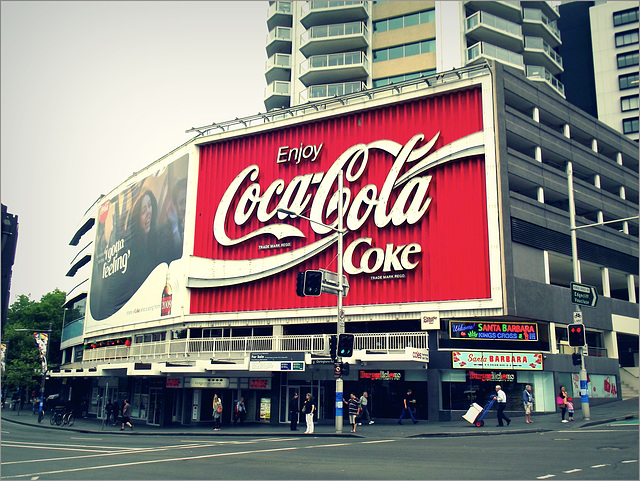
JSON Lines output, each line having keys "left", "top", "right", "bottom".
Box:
{"left": 89, "top": 155, "right": 188, "bottom": 321}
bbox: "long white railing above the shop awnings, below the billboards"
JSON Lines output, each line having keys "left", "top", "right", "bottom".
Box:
{"left": 83, "top": 332, "right": 428, "bottom": 362}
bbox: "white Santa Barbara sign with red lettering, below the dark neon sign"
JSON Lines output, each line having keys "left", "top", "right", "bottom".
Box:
{"left": 451, "top": 351, "right": 542, "bottom": 371}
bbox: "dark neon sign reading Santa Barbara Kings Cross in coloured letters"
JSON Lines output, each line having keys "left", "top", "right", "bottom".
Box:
{"left": 449, "top": 321, "right": 538, "bottom": 341}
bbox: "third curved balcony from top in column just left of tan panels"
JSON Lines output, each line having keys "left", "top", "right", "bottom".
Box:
{"left": 300, "top": 52, "right": 369, "bottom": 87}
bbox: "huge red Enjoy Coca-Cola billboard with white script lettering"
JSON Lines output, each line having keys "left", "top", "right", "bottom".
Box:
{"left": 187, "top": 86, "right": 497, "bottom": 313}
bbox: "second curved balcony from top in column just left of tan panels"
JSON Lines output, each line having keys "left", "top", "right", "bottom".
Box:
{"left": 300, "top": 22, "right": 369, "bottom": 58}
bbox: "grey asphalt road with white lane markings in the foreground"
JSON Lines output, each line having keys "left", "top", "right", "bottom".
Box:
{"left": 1, "top": 419, "right": 640, "bottom": 480}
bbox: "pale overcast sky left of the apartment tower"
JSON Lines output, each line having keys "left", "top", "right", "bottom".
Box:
{"left": 0, "top": 1, "right": 268, "bottom": 303}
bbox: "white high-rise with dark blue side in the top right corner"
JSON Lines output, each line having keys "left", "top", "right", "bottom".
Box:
{"left": 559, "top": 2, "right": 638, "bottom": 140}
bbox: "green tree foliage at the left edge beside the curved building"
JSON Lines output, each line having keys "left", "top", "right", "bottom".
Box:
{"left": 2, "top": 289, "right": 66, "bottom": 392}
